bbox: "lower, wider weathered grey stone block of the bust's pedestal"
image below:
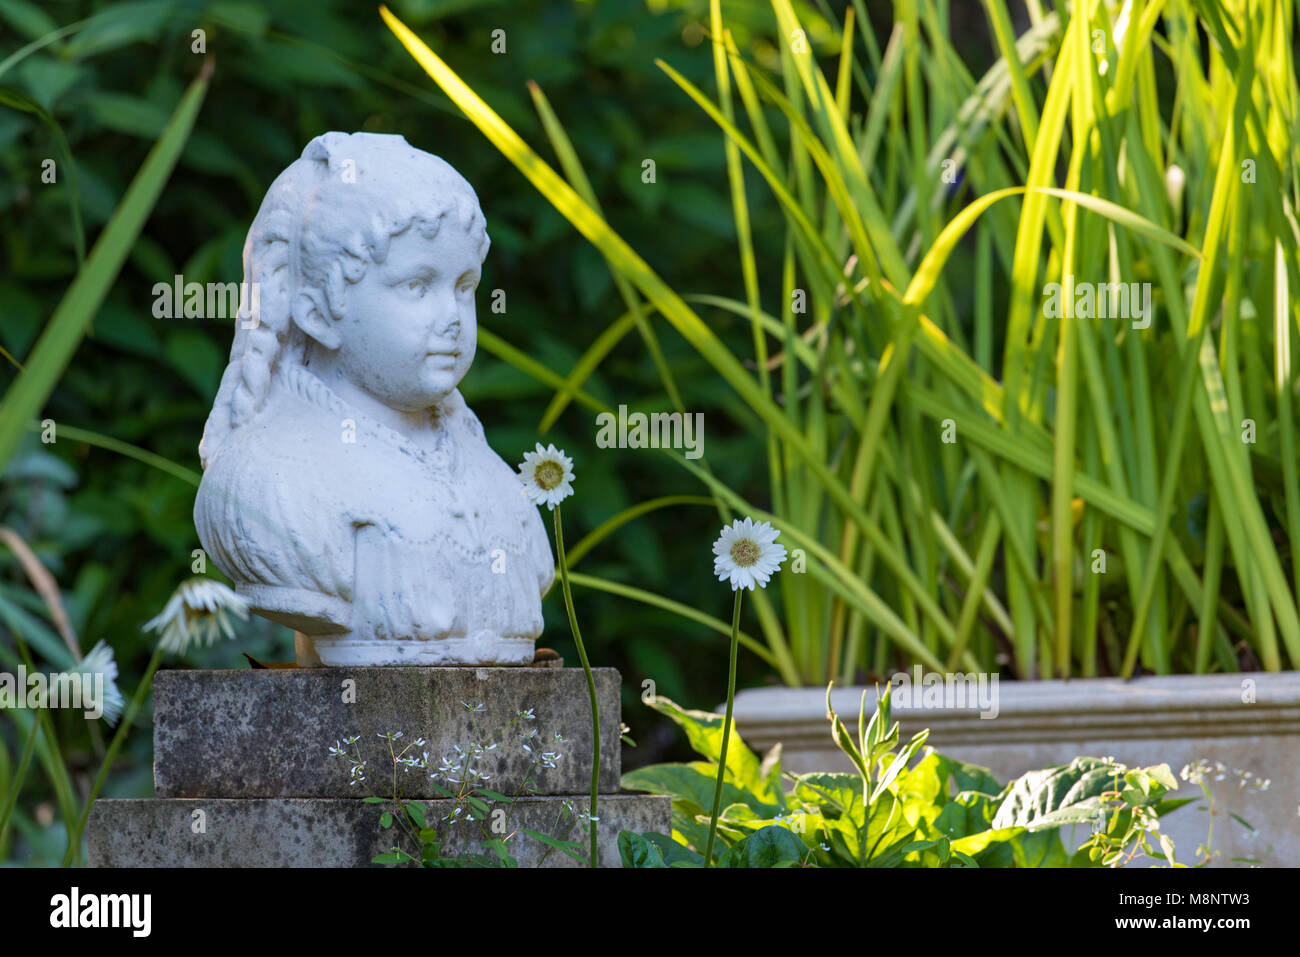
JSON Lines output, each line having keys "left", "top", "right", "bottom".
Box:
{"left": 87, "top": 794, "right": 672, "bottom": 867}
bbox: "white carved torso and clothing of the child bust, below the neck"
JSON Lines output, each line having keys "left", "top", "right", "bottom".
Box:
{"left": 195, "top": 365, "right": 554, "bottom": 640}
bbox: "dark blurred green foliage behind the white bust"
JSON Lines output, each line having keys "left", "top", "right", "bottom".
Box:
{"left": 0, "top": 0, "right": 946, "bottom": 861}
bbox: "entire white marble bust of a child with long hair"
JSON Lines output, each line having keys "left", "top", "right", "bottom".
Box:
{"left": 194, "top": 133, "right": 554, "bottom": 666}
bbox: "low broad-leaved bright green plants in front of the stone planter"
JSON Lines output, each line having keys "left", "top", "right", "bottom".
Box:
{"left": 619, "top": 690, "right": 1186, "bottom": 867}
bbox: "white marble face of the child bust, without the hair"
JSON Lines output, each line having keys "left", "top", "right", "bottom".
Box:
{"left": 327, "top": 218, "right": 481, "bottom": 412}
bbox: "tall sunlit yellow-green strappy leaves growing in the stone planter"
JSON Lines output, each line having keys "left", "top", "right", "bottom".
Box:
{"left": 382, "top": 0, "right": 1300, "bottom": 684}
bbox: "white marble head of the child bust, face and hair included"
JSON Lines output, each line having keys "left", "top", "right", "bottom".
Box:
{"left": 199, "top": 133, "right": 489, "bottom": 465}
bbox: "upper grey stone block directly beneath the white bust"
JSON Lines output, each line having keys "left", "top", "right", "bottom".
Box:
{"left": 153, "top": 667, "right": 621, "bottom": 798}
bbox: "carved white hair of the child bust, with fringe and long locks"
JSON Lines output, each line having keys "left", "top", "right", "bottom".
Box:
{"left": 199, "top": 133, "right": 490, "bottom": 468}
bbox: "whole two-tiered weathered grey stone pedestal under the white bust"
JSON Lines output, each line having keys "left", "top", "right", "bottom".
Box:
{"left": 87, "top": 667, "right": 671, "bottom": 867}
